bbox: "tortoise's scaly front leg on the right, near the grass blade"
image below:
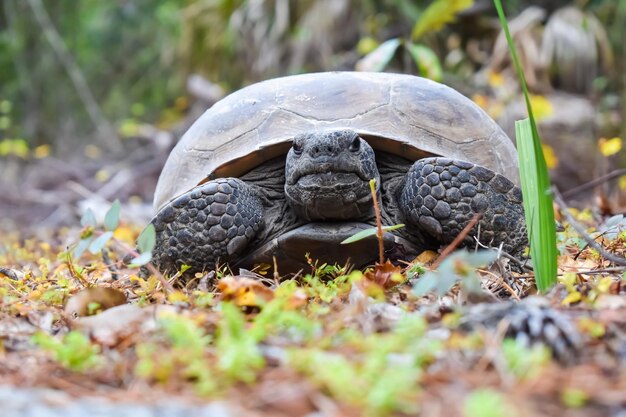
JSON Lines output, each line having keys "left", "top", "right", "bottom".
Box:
{"left": 397, "top": 158, "right": 527, "bottom": 255}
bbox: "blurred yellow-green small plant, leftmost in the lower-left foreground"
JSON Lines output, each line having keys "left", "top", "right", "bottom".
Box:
{"left": 33, "top": 331, "right": 102, "bottom": 372}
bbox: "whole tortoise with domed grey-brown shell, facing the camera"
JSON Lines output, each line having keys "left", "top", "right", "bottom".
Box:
{"left": 152, "top": 72, "right": 527, "bottom": 272}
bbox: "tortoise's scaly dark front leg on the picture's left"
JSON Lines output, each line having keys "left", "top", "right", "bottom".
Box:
{"left": 152, "top": 178, "right": 263, "bottom": 272}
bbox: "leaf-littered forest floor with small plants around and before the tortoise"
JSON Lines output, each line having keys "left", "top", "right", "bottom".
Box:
{"left": 0, "top": 151, "right": 626, "bottom": 417}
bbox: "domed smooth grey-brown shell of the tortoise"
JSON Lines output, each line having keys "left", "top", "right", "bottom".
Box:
{"left": 154, "top": 72, "right": 519, "bottom": 210}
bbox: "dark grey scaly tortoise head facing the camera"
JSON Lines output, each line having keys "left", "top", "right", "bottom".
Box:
{"left": 285, "top": 129, "right": 380, "bottom": 221}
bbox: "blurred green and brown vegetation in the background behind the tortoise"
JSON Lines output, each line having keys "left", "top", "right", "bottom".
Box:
{"left": 0, "top": 0, "right": 626, "bottom": 224}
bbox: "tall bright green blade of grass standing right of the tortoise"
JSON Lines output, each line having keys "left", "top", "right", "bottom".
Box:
{"left": 494, "top": 0, "right": 557, "bottom": 292}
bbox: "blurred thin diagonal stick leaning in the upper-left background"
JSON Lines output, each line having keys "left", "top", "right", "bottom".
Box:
{"left": 27, "top": 0, "right": 122, "bottom": 151}
